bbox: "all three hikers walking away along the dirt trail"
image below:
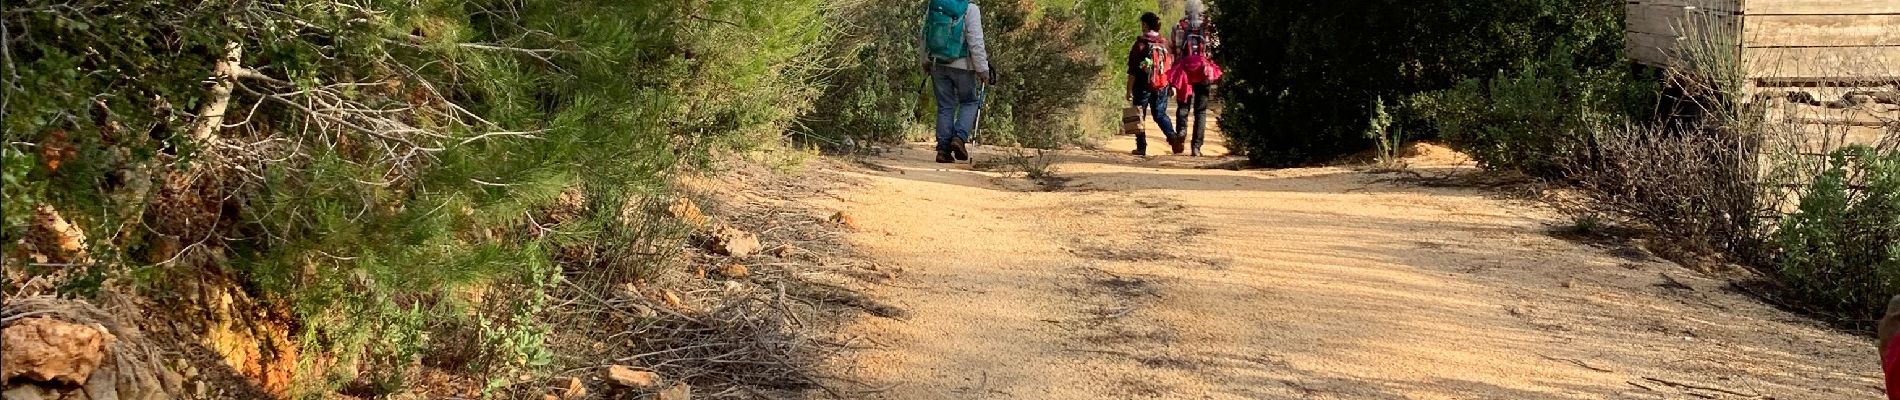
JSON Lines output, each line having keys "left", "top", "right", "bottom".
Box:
{"left": 920, "top": 0, "right": 1222, "bottom": 163}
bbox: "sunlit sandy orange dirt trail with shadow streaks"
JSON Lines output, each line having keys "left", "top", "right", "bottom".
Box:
{"left": 824, "top": 119, "right": 1881, "bottom": 400}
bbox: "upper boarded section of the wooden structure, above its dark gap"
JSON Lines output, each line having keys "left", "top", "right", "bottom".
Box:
{"left": 1626, "top": 0, "right": 1900, "bottom": 87}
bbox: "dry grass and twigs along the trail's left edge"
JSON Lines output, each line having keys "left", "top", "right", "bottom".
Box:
{"left": 511, "top": 161, "right": 889, "bottom": 398}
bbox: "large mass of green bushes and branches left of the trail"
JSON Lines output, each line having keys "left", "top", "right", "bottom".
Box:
{"left": 0, "top": 0, "right": 825, "bottom": 392}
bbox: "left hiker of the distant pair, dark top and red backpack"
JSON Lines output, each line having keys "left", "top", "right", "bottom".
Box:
{"left": 1125, "top": 13, "right": 1182, "bottom": 155}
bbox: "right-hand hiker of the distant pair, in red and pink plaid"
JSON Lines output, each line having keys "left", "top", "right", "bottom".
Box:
{"left": 1169, "top": 0, "right": 1220, "bottom": 157}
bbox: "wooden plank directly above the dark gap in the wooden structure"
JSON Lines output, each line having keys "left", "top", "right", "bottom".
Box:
{"left": 1742, "top": 45, "right": 1900, "bottom": 80}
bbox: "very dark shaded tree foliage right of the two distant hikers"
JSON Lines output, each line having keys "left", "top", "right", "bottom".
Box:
{"left": 1212, "top": 0, "right": 1623, "bottom": 165}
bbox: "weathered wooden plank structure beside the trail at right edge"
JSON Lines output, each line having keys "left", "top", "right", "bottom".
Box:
{"left": 1625, "top": 0, "right": 1900, "bottom": 218}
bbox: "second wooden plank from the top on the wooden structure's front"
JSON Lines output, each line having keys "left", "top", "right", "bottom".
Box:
{"left": 1742, "top": 14, "right": 1900, "bottom": 47}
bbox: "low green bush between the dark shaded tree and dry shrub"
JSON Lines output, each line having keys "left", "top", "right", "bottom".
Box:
{"left": 1412, "top": 47, "right": 1657, "bottom": 176}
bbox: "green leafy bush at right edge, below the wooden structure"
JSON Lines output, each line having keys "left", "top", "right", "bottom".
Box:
{"left": 1775, "top": 146, "right": 1900, "bottom": 320}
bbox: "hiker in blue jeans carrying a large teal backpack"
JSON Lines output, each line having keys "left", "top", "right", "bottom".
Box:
{"left": 920, "top": 0, "right": 996, "bottom": 163}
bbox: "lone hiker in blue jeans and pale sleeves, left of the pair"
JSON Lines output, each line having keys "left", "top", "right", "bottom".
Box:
{"left": 920, "top": 2, "right": 996, "bottom": 163}
